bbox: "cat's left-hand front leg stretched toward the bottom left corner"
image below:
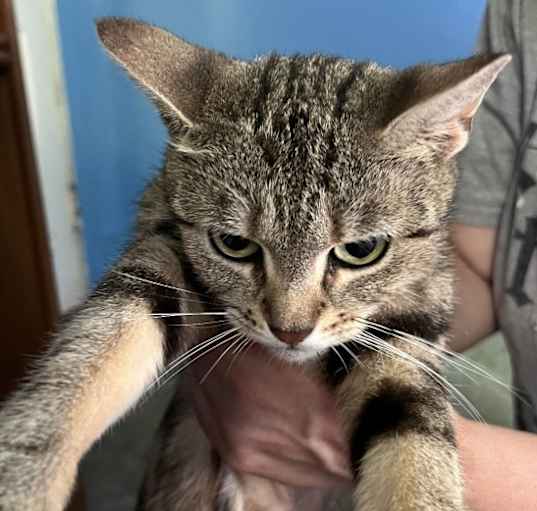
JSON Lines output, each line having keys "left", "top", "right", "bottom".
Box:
{"left": 0, "top": 236, "right": 186, "bottom": 511}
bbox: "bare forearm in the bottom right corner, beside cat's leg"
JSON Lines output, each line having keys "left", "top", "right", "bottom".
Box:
{"left": 456, "top": 417, "right": 537, "bottom": 511}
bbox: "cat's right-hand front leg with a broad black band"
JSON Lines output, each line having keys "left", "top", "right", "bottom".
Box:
{"left": 338, "top": 340, "right": 464, "bottom": 511}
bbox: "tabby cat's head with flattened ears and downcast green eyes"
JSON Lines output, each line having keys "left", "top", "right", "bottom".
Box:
{"left": 98, "top": 18, "right": 509, "bottom": 361}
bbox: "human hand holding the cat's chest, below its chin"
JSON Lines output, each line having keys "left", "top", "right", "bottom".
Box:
{"left": 189, "top": 344, "right": 351, "bottom": 488}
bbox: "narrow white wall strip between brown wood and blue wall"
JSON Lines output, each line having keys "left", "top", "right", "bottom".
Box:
{"left": 14, "top": 0, "right": 87, "bottom": 311}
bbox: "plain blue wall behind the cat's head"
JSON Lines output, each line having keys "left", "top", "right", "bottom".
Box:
{"left": 58, "top": 0, "right": 485, "bottom": 283}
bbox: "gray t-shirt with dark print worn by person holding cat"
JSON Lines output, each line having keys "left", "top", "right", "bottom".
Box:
{"left": 455, "top": 0, "right": 537, "bottom": 432}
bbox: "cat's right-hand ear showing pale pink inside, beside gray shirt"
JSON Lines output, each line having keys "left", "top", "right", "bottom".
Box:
{"left": 382, "top": 54, "right": 511, "bottom": 160}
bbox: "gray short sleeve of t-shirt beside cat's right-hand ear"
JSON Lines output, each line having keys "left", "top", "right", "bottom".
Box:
{"left": 453, "top": 0, "right": 523, "bottom": 228}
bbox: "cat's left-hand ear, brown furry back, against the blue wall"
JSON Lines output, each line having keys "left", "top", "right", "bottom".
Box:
{"left": 96, "top": 17, "right": 233, "bottom": 128}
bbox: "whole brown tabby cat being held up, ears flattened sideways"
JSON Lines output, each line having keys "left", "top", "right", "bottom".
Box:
{"left": 0, "top": 18, "right": 510, "bottom": 511}
